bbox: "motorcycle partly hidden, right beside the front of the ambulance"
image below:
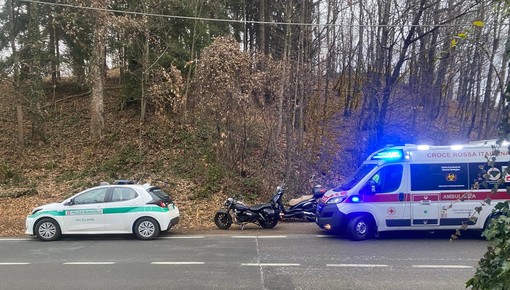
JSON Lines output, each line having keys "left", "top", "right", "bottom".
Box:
{"left": 278, "top": 185, "right": 327, "bottom": 222}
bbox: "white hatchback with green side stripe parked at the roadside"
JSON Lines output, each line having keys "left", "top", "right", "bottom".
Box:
{"left": 25, "top": 181, "right": 179, "bottom": 241}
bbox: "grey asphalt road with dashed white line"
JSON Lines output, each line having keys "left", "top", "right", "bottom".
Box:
{"left": 0, "top": 223, "right": 486, "bottom": 290}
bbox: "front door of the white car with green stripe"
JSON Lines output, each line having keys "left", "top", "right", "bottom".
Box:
{"left": 64, "top": 188, "right": 108, "bottom": 233}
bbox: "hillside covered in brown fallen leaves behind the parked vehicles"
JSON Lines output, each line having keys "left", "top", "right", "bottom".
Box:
{"left": 0, "top": 73, "right": 484, "bottom": 236}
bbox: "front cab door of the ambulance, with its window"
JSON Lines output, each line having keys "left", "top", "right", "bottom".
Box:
{"left": 364, "top": 164, "right": 410, "bottom": 230}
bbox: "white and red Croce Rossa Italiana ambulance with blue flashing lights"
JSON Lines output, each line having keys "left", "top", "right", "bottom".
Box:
{"left": 316, "top": 140, "right": 510, "bottom": 240}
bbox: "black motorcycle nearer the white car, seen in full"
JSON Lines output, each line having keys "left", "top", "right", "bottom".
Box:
{"left": 214, "top": 192, "right": 281, "bottom": 230}
